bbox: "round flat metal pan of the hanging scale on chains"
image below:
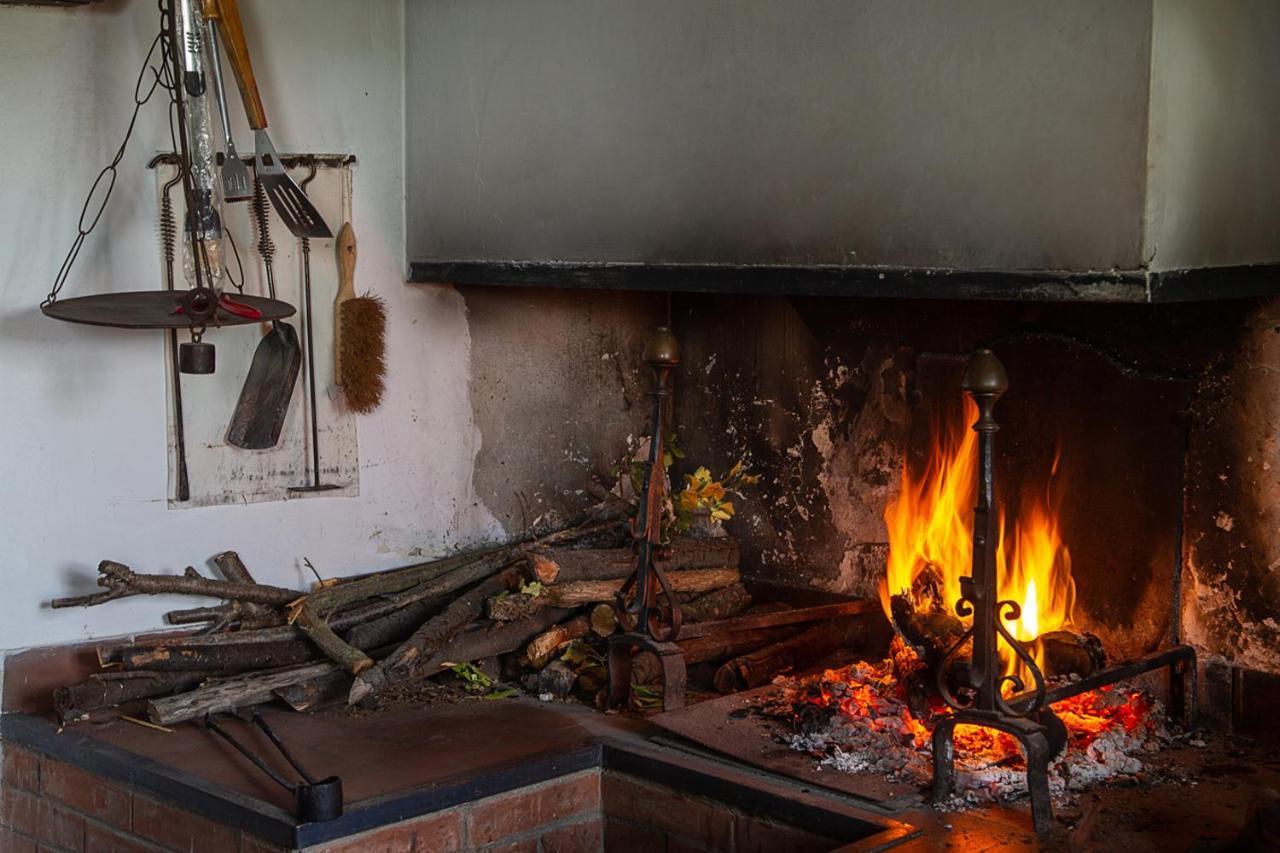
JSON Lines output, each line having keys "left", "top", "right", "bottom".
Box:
{"left": 40, "top": 291, "right": 296, "bottom": 329}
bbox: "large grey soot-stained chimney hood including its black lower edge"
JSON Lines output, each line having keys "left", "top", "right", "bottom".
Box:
{"left": 404, "top": 0, "right": 1280, "bottom": 302}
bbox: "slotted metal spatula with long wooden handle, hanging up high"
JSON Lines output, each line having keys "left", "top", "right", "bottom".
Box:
{"left": 204, "top": 0, "right": 333, "bottom": 238}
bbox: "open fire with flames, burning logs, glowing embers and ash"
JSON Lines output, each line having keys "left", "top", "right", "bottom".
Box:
{"left": 765, "top": 389, "right": 1167, "bottom": 803}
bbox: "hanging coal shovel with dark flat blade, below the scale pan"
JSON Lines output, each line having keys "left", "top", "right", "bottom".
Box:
{"left": 227, "top": 181, "right": 302, "bottom": 450}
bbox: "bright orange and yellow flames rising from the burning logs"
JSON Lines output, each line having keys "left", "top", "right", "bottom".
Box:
{"left": 879, "top": 397, "right": 1075, "bottom": 686}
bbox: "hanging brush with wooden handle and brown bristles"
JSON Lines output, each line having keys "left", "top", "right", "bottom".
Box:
{"left": 333, "top": 222, "right": 387, "bottom": 414}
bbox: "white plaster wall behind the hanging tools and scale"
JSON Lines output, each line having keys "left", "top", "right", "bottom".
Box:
{"left": 0, "top": 0, "right": 497, "bottom": 649}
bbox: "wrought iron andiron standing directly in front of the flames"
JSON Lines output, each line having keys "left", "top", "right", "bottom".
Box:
{"left": 933, "top": 350, "right": 1066, "bottom": 833}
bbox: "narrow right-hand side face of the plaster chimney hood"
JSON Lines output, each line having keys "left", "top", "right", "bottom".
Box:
{"left": 1143, "top": 0, "right": 1280, "bottom": 269}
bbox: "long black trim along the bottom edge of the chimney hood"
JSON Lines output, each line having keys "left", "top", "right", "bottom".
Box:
{"left": 408, "top": 261, "right": 1280, "bottom": 304}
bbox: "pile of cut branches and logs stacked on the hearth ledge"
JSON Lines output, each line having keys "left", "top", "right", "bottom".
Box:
{"left": 52, "top": 501, "right": 878, "bottom": 725}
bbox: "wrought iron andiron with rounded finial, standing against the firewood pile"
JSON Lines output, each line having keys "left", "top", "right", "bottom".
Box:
{"left": 608, "top": 327, "right": 686, "bottom": 711}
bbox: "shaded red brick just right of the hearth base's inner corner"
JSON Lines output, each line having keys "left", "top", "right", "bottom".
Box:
{"left": 603, "top": 772, "right": 733, "bottom": 850}
